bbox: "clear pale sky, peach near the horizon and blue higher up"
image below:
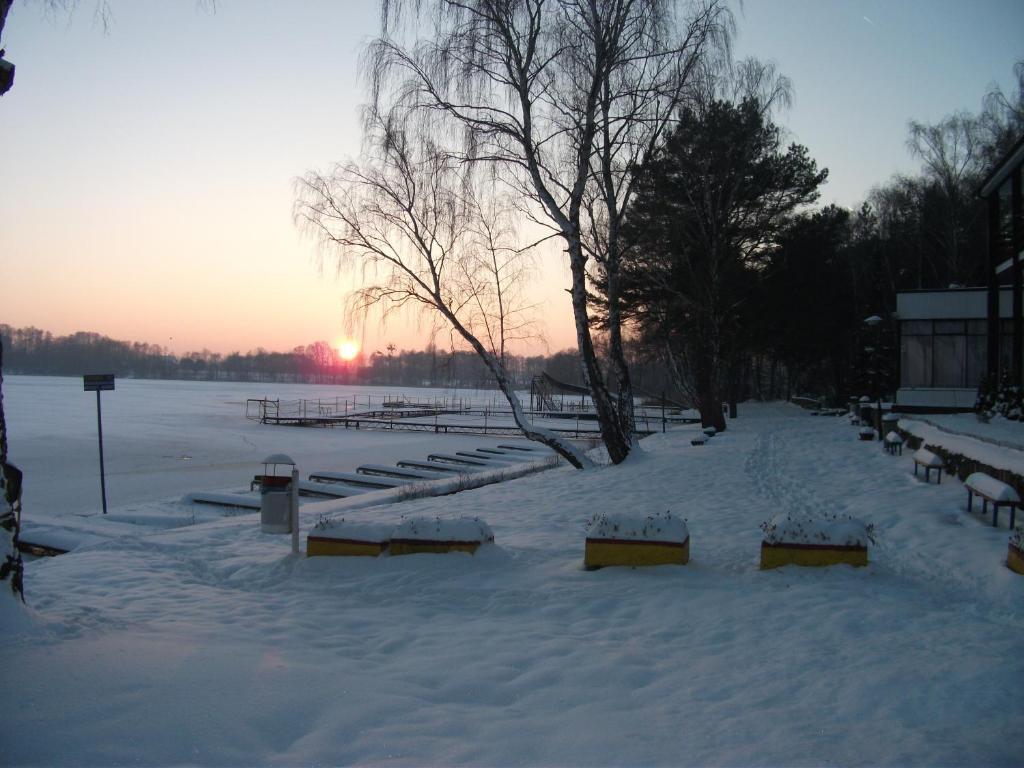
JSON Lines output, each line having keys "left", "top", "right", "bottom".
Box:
{"left": 0, "top": 0, "right": 1024, "bottom": 353}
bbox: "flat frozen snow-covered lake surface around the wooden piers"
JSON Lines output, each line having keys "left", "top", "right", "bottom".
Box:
{"left": 3, "top": 376, "right": 561, "bottom": 519}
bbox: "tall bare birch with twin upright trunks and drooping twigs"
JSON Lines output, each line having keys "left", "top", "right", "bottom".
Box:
{"left": 368, "top": 0, "right": 731, "bottom": 463}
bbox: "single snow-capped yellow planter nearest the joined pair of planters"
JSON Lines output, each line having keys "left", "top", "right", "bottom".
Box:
{"left": 584, "top": 511, "right": 690, "bottom": 568}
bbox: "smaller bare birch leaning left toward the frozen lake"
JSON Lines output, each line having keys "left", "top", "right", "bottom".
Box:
{"left": 295, "top": 122, "right": 590, "bottom": 468}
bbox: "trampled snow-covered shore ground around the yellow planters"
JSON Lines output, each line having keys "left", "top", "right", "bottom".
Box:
{"left": 0, "top": 397, "right": 1024, "bottom": 766}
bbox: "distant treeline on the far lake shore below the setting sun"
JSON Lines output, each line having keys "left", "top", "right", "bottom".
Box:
{"left": 0, "top": 324, "right": 669, "bottom": 395}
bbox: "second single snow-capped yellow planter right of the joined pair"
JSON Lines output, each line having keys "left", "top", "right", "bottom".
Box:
{"left": 761, "top": 513, "right": 871, "bottom": 569}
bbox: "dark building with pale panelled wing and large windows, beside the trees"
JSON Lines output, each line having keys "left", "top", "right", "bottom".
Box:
{"left": 894, "top": 137, "right": 1024, "bottom": 412}
